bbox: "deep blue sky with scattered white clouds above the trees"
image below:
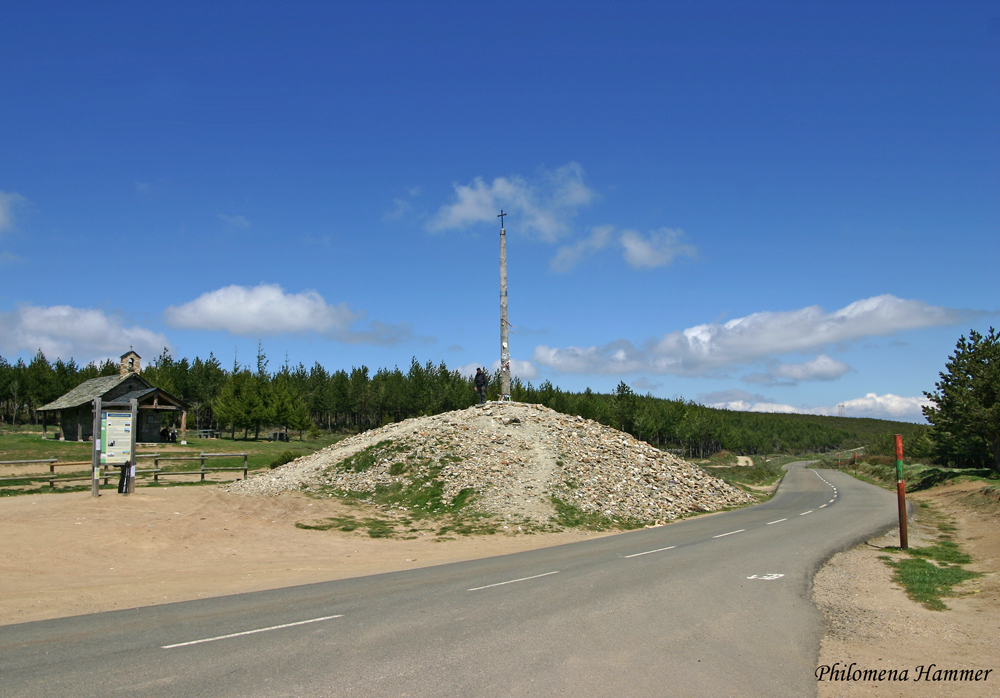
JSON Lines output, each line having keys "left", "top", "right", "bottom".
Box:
{"left": 0, "top": 2, "right": 1000, "bottom": 421}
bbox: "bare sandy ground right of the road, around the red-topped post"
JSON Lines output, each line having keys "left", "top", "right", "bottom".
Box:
{"left": 813, "top": 482, "right": 1000, "bottom": 698}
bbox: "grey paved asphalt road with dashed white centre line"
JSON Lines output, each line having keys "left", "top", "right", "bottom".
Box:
{"left": 0, "top": 463, "right": 896, "bottom": 698}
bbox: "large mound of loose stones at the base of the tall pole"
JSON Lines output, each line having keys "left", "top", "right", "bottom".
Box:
{"left": 229, "top": 403, "right": 754, "bottom": 523}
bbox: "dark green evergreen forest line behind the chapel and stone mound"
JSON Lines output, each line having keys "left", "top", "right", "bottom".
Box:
{"left": 0, "top": 349, "right": 930, "bottom": 458}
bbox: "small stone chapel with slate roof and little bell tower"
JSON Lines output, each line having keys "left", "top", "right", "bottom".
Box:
{"left": 38, "top": 351, "right": 188, "bottom": 443}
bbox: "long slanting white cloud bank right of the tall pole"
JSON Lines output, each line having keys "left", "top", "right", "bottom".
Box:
{"left": 533, "top": 295, "right": 981, "bottom": 380}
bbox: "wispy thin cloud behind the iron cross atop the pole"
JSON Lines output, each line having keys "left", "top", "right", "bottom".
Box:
{"left": 427, "top": 162, "right": 594, "bottom": 242}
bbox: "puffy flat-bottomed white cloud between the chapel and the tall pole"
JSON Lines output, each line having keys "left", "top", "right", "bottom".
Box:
{"left": 164, "top": 284, "right": 410, "bottom": 344}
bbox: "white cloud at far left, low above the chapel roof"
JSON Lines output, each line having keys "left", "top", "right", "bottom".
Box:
{"left": 0, "top": 305, "right": 171, "bottom": 362}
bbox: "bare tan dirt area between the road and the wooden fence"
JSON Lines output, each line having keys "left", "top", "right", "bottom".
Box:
{"left": 0, "top": 487, "right": 601, "bottom": 624}
